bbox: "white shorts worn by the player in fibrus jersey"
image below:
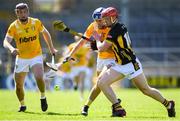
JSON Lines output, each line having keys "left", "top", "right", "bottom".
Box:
{"left": 14, "top": 55, "right": 43, "bottom": 73}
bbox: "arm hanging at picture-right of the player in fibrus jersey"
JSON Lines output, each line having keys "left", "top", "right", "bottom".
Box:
{"left": 42, "top": 27, "right": 57, "bottom": 55}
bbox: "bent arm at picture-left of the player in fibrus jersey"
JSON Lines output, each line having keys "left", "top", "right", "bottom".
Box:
{"left": 3, "top": 35, "right": 19, "bottom": 55}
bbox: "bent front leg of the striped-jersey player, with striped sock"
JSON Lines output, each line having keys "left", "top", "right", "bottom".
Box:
{"left": 97, "top": 68, "right": 126, "bottom": 117}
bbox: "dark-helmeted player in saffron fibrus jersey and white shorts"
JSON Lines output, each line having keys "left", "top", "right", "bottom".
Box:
{"left": 3, "top": 3, "right": 57, "bottom": 112}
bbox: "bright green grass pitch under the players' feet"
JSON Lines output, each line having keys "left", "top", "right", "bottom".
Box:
{"left": 0, "top": 89, "right": 180, "bottom": 121}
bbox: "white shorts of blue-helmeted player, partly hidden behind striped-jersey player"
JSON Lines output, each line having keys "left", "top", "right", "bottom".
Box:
{"left": 96, "top": 58, "right": 116, "bottom": 72}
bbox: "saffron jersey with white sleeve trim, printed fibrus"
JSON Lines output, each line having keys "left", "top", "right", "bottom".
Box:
{"left": 6, "top": 17, "right": 44, "bottom": 59}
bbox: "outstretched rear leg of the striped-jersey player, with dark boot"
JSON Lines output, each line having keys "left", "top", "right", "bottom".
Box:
{"left": 132, "top": 73, "right": 175, "bottom": 117}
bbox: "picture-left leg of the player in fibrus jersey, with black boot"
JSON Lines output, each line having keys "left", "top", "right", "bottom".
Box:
{"left": 14, "top": 72, "right": 27, "bottom": 112}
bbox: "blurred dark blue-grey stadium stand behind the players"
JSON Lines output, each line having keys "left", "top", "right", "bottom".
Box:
{"left": 0, "top": 0, "right": 180, "bottom": 89}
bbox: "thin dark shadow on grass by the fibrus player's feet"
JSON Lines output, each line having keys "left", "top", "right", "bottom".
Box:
{"left": 24, "top": 111, "right": 81, "bottom": 116}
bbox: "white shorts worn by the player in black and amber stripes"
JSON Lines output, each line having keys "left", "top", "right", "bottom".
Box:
{"left": 111, "top": 59, "right": 143, "bottom": 79}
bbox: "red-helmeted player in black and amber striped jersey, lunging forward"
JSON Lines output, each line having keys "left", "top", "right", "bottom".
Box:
{"left": 97, "top": 7, "right": 176, "bottom": 117}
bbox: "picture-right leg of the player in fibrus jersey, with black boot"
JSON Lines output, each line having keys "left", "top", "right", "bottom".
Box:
{"left": 31, "top": 63, "right": 48, "bottom": 111}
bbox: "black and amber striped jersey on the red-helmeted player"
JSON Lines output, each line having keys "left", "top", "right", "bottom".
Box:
{"left": 106, "top": 23, "right": 136, "bottom": 65}
